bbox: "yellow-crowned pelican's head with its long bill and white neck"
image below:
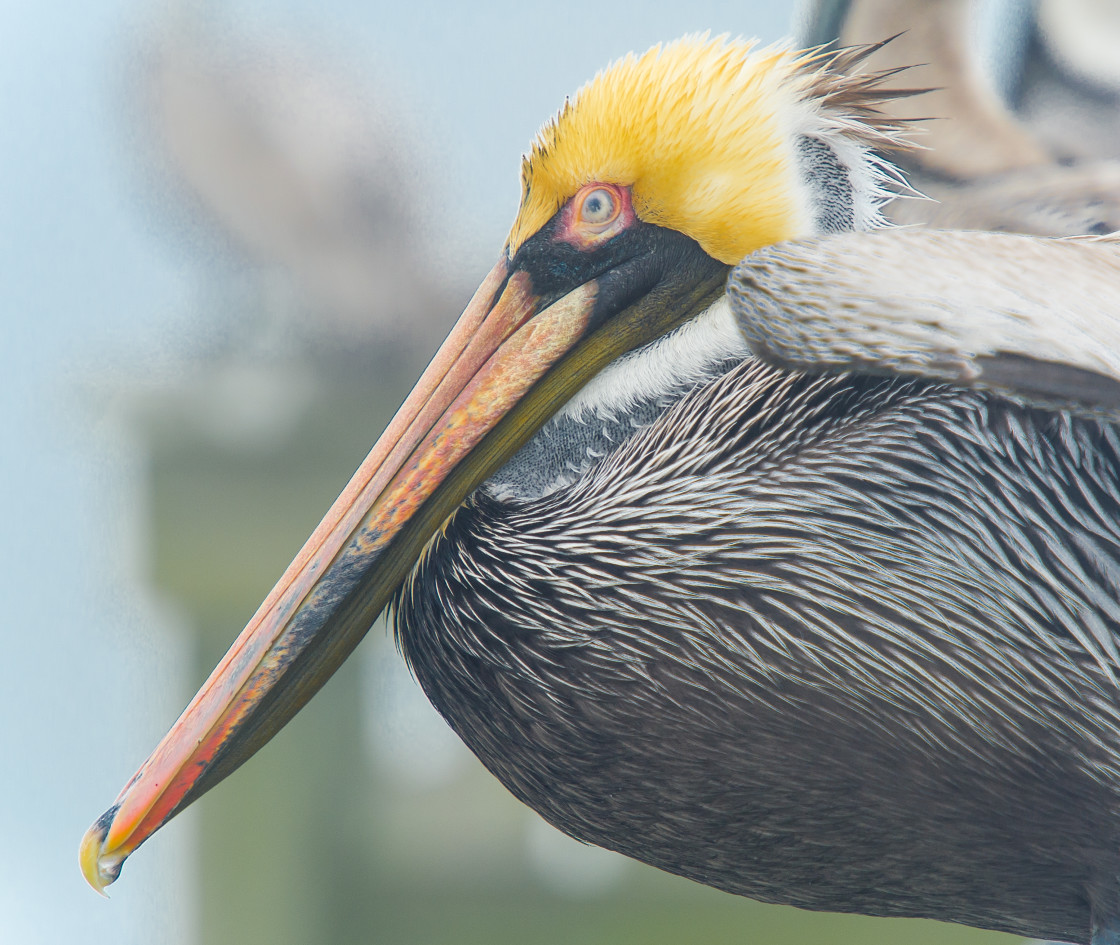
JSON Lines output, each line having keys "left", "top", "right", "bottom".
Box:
{"left": 81, "top": 37, "right": 900, "bottom": 890}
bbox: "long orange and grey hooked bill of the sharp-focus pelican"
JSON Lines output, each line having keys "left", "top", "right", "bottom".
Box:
{"left": 80, "top": 238, "right": 726, "bottom": 892}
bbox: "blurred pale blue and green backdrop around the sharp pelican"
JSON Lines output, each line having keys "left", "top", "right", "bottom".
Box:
{"left": 8, "top": 0, "right": 1120, "bottom": 945}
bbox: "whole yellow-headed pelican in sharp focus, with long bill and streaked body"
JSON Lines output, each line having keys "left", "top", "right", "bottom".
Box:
{"left": 81, "top": 37, "right": 1120, "bottom": 945}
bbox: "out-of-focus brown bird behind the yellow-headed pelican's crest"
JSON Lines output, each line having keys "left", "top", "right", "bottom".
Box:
{"left": 801, "top": 0, "right": 1120, "bottom": 236}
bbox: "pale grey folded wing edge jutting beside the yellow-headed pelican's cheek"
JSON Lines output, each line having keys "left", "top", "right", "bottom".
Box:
{"left": 728, "top": 230, "right": 1120, "bottom": 420}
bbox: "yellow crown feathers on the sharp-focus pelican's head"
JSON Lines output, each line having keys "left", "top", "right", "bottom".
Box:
{"left": 510, "top": 37, "right": 809, "bottom": 263}
